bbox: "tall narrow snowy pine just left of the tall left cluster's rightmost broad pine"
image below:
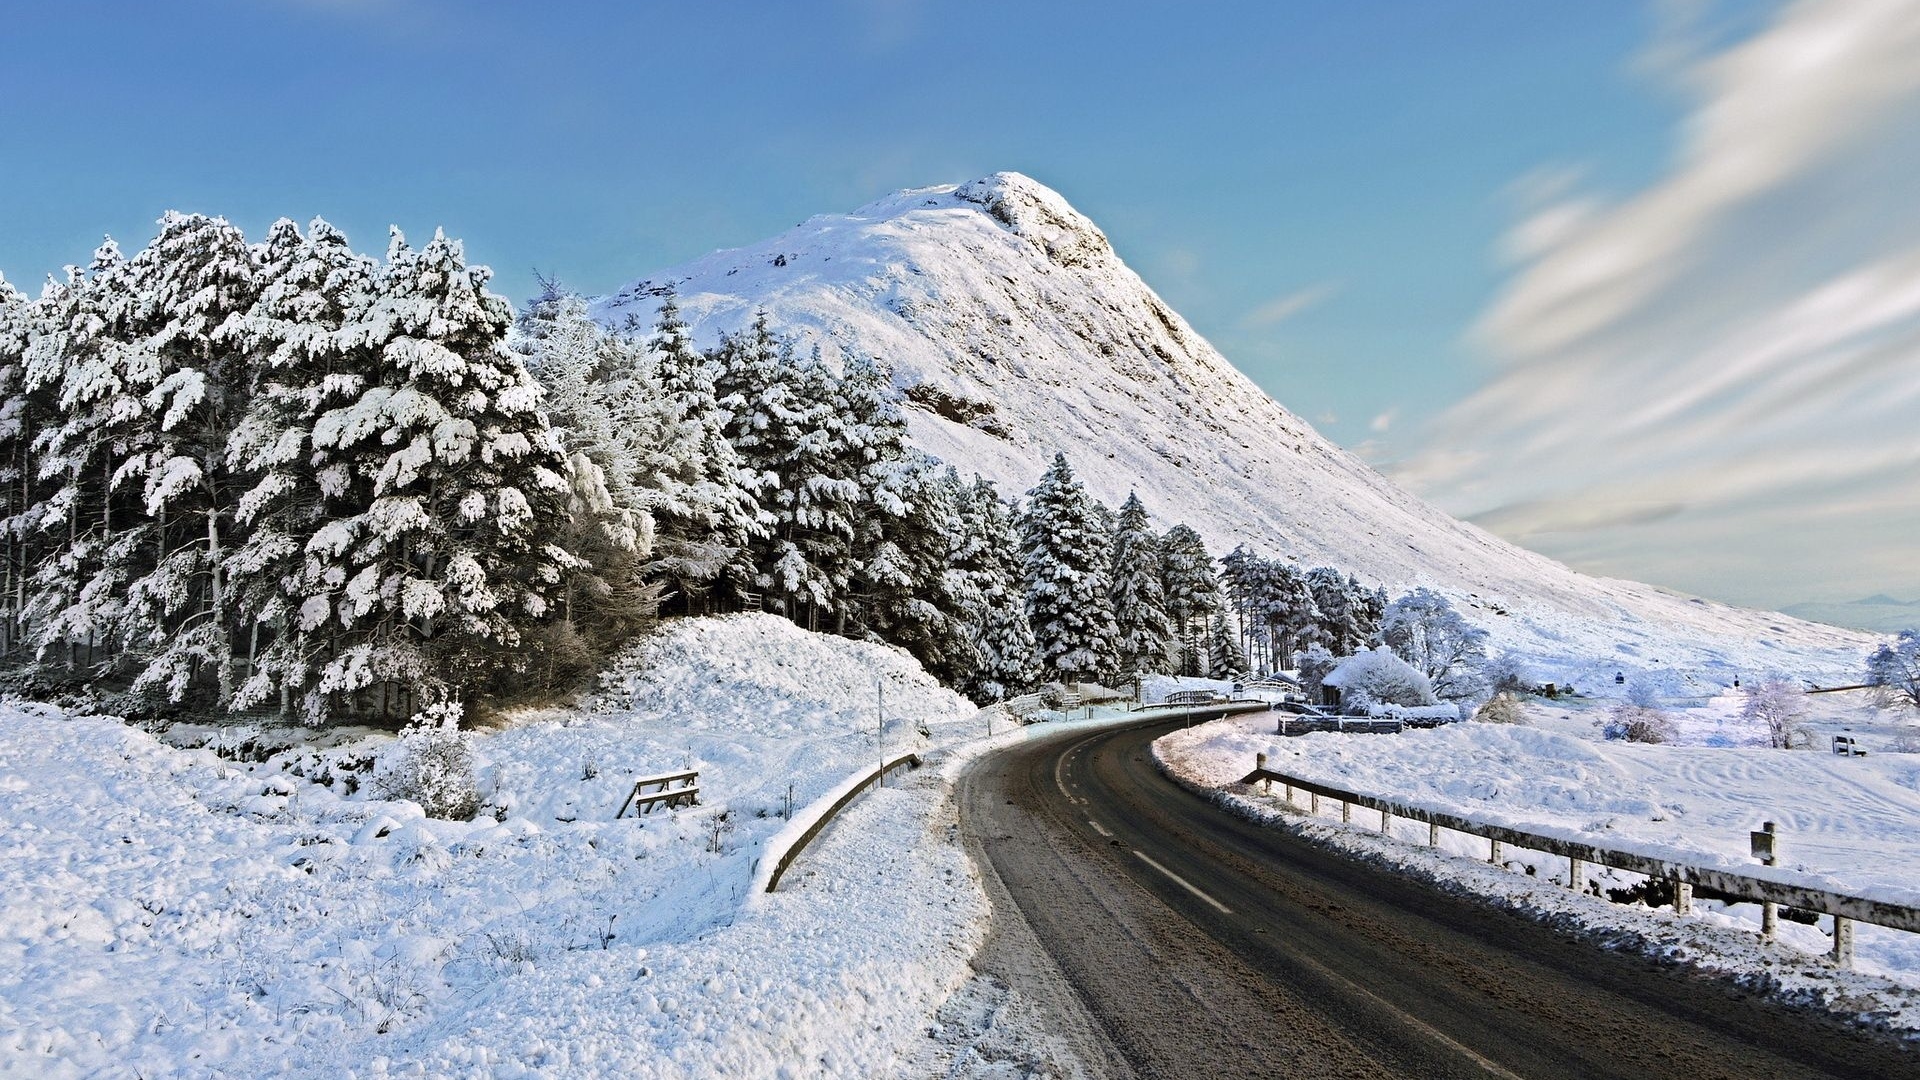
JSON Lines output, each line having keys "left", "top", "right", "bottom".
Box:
{"left": 219, "top": 217, "right": 380, "bottom": 721}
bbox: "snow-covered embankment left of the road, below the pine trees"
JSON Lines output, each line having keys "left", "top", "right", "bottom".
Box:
{"left": 0, "top": 617, "right": 1052, "bottom": 1076}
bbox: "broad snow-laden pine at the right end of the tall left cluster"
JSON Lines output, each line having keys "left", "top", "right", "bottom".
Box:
{"left": 288, "top": 231, "right": 574, "bottom": 719}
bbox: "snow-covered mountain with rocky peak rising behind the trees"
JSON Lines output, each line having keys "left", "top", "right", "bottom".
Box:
{"left": 593, "top": 173, "right": 1868, "bottom": 684}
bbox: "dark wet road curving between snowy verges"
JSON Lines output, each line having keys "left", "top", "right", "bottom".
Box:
{"left": 960, "top": 721, "right": 1920, "bottom": 1080}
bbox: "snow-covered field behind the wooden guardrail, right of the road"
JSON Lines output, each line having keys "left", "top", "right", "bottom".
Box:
{"left": 1156, "top": 717, "right": 1920, "bottom": 999}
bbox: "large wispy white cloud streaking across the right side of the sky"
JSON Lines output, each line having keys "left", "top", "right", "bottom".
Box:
{"left": 1398, "top": 0, "right": 1920, "bottom": 603}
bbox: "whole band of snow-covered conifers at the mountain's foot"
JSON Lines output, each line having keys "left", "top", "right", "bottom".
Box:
{"left": 0, "top": 213, "right": 1443, "bottom": 724}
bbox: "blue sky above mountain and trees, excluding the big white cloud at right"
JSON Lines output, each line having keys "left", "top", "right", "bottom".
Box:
{"left": 0, "top": 0, "right": 1920, "bottom": 603}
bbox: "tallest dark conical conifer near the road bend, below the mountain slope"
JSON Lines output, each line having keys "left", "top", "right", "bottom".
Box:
{"left": 1020, "top": 454, "right": 1119, "bottom": 682}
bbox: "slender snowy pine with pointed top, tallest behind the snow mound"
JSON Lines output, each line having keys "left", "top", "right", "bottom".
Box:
{"left": 647, "top": 292, "right": 766, "bottom": 613}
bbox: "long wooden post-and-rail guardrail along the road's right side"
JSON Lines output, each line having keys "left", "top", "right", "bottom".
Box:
{"left": 1240, "top": 755, "right": 1920, "bottom": 967}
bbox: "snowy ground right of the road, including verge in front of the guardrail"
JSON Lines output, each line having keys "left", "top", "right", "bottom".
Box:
{"left": 1154, "top": 717, "right": 1920, "bottom": 1032}
